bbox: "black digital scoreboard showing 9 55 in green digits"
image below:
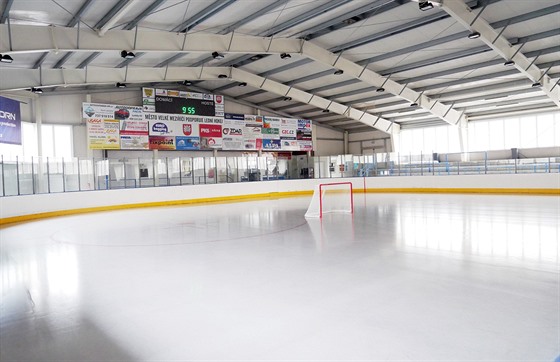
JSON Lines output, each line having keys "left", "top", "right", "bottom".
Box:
{"left": 155, "top": 95, "right": 216, "bottom": 117}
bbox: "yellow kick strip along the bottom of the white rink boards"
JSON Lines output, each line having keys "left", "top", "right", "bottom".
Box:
{"left": 0, "top": 187, "right": 560, "bottom": 226}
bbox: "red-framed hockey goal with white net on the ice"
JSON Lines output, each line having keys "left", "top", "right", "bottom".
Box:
{"left": 305, "top": 182, "right": 354, "bottom": 218}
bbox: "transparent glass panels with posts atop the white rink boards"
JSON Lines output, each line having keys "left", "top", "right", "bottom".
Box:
{"left": 0, "top": 152, "right": 560, "bottom": 196}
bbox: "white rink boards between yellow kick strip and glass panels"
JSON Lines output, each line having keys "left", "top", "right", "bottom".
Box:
{"left": 0, "top": 174, "right": 560, "bottom": 219}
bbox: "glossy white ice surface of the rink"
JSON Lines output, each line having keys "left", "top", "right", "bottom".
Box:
{"left": 0, "top": 194, "right": 560, "bottom": 361}
